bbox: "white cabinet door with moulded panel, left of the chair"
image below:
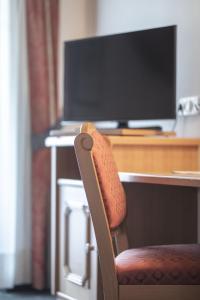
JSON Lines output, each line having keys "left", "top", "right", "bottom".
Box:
{"left": 58, "top": 180, "right": 97, "bottom": 300}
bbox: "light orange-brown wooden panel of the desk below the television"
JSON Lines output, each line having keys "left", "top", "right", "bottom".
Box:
{"left": 109, "top": 136, "right": 200, "bottom": 172}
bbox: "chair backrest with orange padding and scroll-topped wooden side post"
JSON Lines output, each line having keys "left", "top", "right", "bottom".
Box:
{"left": 75, "top": 123, "right": 127, "bottom": 299}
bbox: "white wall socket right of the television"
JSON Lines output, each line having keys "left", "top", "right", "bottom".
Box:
{"left": 178, "top": 96, "right": 200, "bottom": 116}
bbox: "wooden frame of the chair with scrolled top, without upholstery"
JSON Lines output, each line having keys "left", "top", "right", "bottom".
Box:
{"left": 74, "top": 123, "right": 200, "bottom": 300}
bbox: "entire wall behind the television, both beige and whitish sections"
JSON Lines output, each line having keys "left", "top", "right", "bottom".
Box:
{"left": 59, "top": 0, "right": 200, "bottom": 137}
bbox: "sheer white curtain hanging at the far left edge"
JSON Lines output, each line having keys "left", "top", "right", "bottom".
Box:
{"left": 0, "top": 0, "right": 31, "bottom": 288}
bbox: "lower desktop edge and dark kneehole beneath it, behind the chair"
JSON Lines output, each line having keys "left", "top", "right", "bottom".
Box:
{"left": 119, "top": 172, "right": 200, "bottom": 255}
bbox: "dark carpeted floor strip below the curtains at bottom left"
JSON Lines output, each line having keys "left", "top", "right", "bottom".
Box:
{"left": 0, "top": 291, "right": 56, "bottom": 300}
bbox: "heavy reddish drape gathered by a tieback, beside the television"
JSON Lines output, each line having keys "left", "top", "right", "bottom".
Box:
{"left": 26, "top": 0, "right": 59, "bottom": 289}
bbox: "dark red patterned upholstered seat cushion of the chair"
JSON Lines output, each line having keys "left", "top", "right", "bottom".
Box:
{"left": 115, "top": 244, "right": 200, "bottom": 285}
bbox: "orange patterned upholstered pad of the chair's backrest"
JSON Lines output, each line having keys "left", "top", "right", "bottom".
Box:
{"left": 91, "top": 130, "right": 126, "bottom": 229}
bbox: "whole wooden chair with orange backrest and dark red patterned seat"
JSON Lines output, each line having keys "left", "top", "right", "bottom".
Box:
{"left": 75, "top": 123, "right": 200, "bottom": 300}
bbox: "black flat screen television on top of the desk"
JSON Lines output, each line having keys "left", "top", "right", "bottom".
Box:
{"left": 64, "top": 26, "right": 176, "bottom": 127}
